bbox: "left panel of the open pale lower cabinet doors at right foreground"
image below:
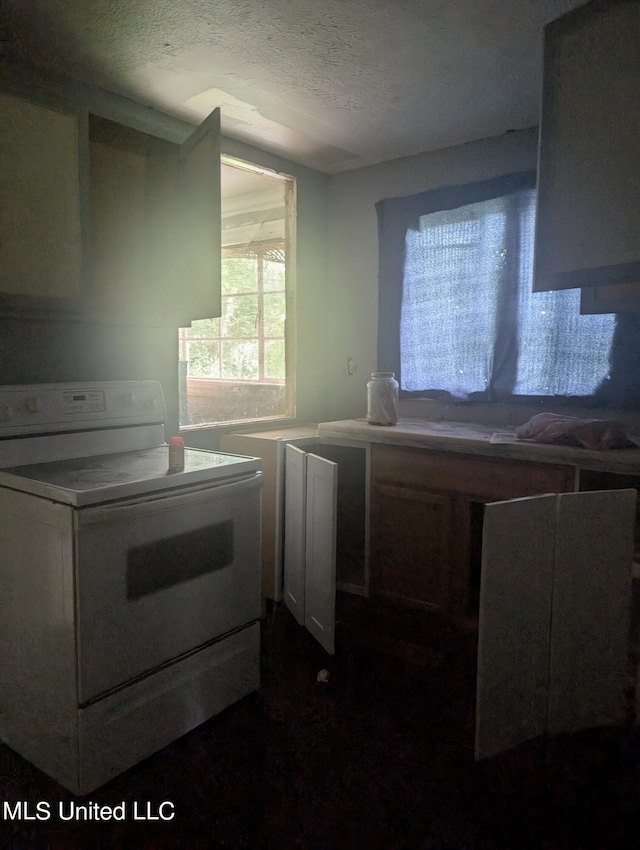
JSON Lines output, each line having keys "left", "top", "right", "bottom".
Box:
{"left": 476, "top": 495, "right": 556, "bottom": 759}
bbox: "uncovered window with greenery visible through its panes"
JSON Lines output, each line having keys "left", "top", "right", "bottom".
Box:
{"left": 179, "top": 160, "right": 295, "bottom": 427}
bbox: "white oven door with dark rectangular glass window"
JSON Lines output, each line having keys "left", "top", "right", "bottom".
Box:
{"left": 75, "top": 473, "right": 262, "bottom": 704}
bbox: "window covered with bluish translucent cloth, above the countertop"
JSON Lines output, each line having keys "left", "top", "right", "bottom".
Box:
{"left": 379, "top": 174, "right": 615, "bottom": 400}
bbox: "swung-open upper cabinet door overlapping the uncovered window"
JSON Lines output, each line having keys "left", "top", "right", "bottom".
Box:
{"left": 180, "top": 103, "right": 221, "bottom": 324}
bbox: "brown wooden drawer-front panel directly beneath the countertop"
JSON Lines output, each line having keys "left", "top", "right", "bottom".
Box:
{"left": 371, "top": 446, "right": 575, "bottom": 501}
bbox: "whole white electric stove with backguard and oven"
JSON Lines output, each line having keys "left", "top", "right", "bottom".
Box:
{"left": 0, "top": 381, "right": 262, "bottom": 794}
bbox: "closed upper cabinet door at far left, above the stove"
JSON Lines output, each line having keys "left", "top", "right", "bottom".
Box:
{"left": 0, "top": 93, "right": 86, "bottom": 314}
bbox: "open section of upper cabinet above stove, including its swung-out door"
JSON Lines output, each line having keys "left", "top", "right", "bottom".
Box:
{"left": 89, "top": 110, "right": 221, "bottom": 327}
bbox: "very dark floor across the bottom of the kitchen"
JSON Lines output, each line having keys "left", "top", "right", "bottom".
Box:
{"left": 0, "top": 595, "right": 640, "bottom": 850}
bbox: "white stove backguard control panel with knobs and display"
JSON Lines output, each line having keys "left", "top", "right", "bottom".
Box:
{"left": 0, "top": 381, "right": 165, "bottom": 437}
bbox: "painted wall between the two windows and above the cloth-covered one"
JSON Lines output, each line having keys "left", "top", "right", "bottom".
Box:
{"left": 324, "top": 128, "right": 538, "bottom": 420}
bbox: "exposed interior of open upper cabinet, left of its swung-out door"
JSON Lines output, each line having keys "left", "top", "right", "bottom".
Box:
{"left": 89, "top": 115, "right": 184, "bottom": 327}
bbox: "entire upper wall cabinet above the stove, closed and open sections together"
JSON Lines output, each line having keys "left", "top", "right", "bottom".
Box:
{"left": 0, "top": 81, "right": 220, "bottom": 327}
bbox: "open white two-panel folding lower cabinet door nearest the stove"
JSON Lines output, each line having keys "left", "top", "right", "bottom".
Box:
{"left": 284, "top": 445, "right": 338, "bottom": 655}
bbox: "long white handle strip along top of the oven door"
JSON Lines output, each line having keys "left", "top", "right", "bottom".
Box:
{"left": 74, "top": 472, "right": 263, "bottom": 528}
